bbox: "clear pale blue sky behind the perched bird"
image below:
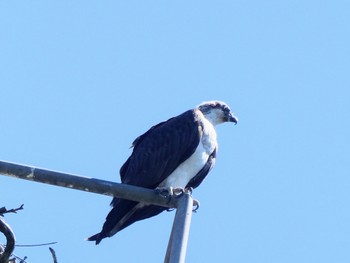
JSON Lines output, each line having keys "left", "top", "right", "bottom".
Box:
{"left": 0, "top": 0, "right": 350, "bottom": 263}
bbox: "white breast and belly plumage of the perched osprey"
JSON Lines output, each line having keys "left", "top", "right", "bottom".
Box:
{"left": 159, "top": 118, "right": 217, "bottom": 188}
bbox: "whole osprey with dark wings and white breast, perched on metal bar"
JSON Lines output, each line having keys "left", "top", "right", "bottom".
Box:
{"left": 88, "top": 101, "right": 237, "bottom": 244}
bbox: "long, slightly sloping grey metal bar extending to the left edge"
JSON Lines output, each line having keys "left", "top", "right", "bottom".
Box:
{"left": 0, "top": 161, "right": 177, "bottom": 208}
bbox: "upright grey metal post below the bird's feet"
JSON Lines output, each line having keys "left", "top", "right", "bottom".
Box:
{"left": 164, "top": 193, "right": 193, "bottom": 263}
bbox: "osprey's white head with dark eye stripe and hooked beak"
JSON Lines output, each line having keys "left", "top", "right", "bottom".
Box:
{"left": 197, "top": 101, "right": 238, "bottom": 125}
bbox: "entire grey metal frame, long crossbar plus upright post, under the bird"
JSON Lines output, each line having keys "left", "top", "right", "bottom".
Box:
{"left": 0, "top": 161, "right": 196, "bottom": 263}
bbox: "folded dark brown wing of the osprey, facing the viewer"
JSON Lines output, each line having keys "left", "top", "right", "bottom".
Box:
{"left": 120, "top": 110, "right": 200, "bottom": 188}
